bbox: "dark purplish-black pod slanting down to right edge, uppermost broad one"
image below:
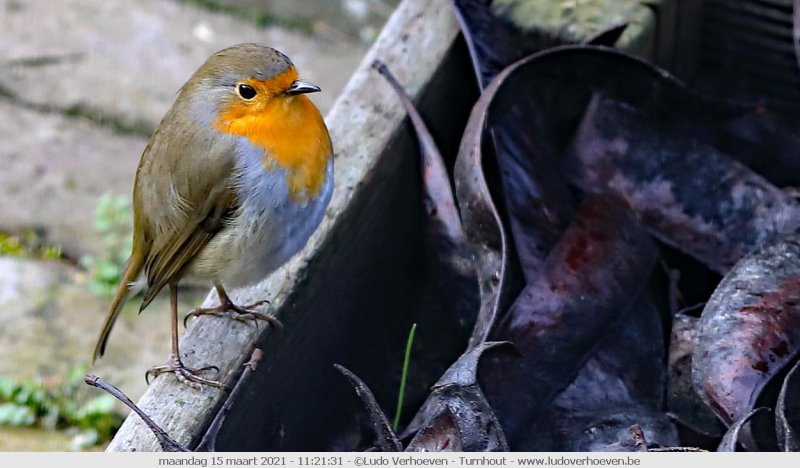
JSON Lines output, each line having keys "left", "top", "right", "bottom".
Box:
{"left": 567, "top": 96, "right": 800, "bottom": 273}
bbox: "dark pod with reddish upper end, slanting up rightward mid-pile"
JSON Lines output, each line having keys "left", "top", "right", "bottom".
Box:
{"left": 480, "top": 195, "right": 657, "bottom": 443}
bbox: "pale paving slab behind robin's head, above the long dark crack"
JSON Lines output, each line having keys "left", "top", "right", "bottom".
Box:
{"left": 0, "top": 0, "right": 366, "bottom": 131}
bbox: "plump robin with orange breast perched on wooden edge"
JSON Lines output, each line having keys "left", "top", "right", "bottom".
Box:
{"left": 92, "top": 44, "right": 333, "bottom": 387}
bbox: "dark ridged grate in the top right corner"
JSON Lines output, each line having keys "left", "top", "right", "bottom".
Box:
{"left": 698, "top": 0, "right": 800, "bottom": 114}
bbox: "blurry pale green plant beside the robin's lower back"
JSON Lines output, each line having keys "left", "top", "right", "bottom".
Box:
{"left": 80, "top": 193, "right": 133, "bottom": 297}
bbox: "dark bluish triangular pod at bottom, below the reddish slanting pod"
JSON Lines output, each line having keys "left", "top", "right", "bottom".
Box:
{"left": 518, "top": 291, "right": 678, "bottom": 451}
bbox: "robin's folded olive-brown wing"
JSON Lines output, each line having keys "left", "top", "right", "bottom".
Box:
{"left": 133, "top": 104, "right": 238, "bottom": 309}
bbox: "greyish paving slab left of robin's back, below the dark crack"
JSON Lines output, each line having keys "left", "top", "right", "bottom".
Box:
{"left": 0, "top": 100, "right": 142, "bottom": 258}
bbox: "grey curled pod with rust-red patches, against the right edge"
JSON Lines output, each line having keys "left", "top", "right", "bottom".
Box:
{"left": 692, "top": 234, "right": 800, "bottom": 424}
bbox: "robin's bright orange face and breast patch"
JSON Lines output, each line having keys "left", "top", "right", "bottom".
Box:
{"left": 214, "top": 69, "right": 332, "bottom": 200}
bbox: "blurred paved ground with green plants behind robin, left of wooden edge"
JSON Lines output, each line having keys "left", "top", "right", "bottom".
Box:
{"left": 0, "top": 0, "right": 399, "bottom": 451}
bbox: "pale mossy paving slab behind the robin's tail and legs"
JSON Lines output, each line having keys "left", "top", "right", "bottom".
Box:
{"left": 0, "top": 257, "right": 204, "bottom": 410}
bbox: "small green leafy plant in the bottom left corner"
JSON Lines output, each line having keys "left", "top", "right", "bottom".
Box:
{"left": 0, "top": 366, "right": 123, "bottom": 448}
